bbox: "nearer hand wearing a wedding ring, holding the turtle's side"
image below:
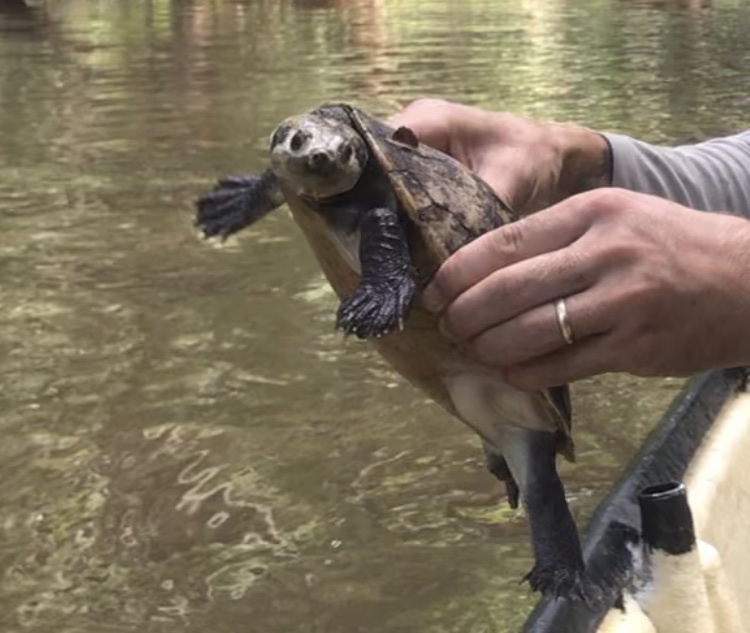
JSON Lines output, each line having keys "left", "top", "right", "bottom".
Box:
{"left": 423, "top": 188, "right": 750, "bottom": 389}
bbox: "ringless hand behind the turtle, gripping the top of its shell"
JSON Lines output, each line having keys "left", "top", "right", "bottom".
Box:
{"left": 389, "top": 99, "right": 611, "bottom": 215}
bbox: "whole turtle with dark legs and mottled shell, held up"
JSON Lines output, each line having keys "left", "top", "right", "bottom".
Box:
{"left": 195, "top": 103, "right": 596, "bottom": 603}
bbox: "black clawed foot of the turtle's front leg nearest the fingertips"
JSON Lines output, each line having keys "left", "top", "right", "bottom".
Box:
{"left": 336, "top": 276, "right": 417, "bottom": 339}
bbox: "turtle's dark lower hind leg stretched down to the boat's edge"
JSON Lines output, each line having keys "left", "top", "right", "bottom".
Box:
{"left": 506, "top": 429, "right": 601, "bottom": 605}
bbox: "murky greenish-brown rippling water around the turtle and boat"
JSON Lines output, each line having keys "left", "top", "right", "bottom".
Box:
{"left": 0, "top": 0, "right": 750, "bottom": 633}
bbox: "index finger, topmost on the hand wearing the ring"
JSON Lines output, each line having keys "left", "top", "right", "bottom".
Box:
{"left": 423, "top": 196, "right": 591, "bottom": 312}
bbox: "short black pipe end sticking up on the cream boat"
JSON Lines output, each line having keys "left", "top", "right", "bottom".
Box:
{"left": 638, "top": 482, "right": 695, "bottom": 556}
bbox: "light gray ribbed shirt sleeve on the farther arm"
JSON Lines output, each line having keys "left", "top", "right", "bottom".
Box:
{"left": 605, "top": 131, "right": 750, "bottom": 217}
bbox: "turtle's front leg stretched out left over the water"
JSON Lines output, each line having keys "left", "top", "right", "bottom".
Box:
{"left": 195, "top": 170, "right": 284, "bottom": 239}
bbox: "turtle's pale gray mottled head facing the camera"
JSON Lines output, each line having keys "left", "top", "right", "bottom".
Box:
{"left": 271, "top": 114, "right": 368, "bottom": 200}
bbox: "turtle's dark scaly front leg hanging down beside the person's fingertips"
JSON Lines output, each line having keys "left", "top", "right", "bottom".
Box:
{"left": 336, "top": 207, "right": 417, "bottom": 339}
